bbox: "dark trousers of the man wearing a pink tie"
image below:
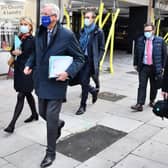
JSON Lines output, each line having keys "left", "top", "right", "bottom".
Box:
{"left": 137, "top": 65, "right": 157, "bottom": 105}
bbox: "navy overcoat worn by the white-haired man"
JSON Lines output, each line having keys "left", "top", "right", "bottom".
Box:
{"left": 26, "top": 24, "right": 85, "bottom": 99}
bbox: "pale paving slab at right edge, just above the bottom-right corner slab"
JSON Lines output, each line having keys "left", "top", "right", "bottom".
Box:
{"left": 133, "top": 141, "right": 168, "bottom": 165}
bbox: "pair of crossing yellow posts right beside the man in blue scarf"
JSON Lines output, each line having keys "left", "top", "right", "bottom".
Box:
{"left": 100, "top": 8, "right": 120, "bottom": 73}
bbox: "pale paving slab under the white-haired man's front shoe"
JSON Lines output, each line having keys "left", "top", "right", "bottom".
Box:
{"left": 5, "top": 144, "right": 80, "bottom": 168}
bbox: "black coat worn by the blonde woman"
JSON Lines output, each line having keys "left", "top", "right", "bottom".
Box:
{"left": 14, "top": 35, "right": 34, "bottom": 92}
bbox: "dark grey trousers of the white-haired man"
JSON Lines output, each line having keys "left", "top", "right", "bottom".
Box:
{"left": 39, "top": 99, "right": 62, "bottom": 155}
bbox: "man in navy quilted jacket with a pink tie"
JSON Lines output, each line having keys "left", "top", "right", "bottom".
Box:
{"left": 131, "top": 24, "right": 167, "bottom": 112}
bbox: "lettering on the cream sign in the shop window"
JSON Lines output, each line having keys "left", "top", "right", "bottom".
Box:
{"left": 0, "top": 4, "right": 25, "bottom": 18}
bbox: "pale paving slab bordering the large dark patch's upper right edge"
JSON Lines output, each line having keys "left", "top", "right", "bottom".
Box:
{"left": 99, "top": 115, "right": 143, "bottom": 133}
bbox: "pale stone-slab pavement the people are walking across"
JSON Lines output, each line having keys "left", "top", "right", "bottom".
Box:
{"left": 0, "top": 53, "right": 168, "bottom": 168}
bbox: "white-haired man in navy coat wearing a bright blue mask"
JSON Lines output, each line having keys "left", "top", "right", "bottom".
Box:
{"left": 24, "top": 4, "right": 84, "bottom": 168}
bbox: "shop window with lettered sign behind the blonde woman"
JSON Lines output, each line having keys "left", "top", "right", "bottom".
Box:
{"left": 0, "top": 0, "right": 36, "bottom": 51}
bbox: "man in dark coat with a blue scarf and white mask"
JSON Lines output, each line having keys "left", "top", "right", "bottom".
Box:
{"left": 76, "top": 11, "right": 105, "bottom": 115}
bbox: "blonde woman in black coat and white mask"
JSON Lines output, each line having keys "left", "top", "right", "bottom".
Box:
{"left": 4, "top": 17, "right": 38, "bottom": 133}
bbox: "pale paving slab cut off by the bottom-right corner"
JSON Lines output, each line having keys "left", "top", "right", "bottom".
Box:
{"left": 113, "top": 155, "right": 168, "bottom": 168}
